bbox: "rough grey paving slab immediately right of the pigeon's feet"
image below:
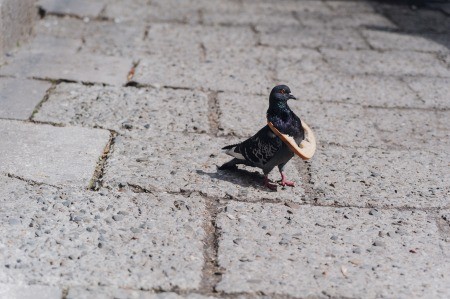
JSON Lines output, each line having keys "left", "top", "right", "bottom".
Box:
{"left": 310, "top": 145, "right": 450, "bottom": 208}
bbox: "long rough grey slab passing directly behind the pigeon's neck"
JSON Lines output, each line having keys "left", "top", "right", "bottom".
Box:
{"left": 218, "top": 91, "right": 450, "bottom": 151}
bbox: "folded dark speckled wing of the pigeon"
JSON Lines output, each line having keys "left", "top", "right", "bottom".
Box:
{"left": 236, "top": 126, "right": 283, "bottom": 167}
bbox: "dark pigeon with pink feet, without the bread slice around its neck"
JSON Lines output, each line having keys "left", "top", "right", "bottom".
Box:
{"left": 219, "top": 85, "right": 305, "bottom": 190}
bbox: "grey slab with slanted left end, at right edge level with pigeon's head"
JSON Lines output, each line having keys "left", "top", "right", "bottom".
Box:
{"left": 404, "top": 77, "right": 450, "bottom": 109}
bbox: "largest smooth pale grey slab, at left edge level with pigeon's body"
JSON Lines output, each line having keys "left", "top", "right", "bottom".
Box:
{"left": 0, "top": 120, "right": 110, "bottom": 187}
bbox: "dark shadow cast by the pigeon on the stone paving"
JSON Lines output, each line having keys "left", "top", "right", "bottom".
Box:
{"left": 196, "top": 165, "right": 268, "bottom": 191}
